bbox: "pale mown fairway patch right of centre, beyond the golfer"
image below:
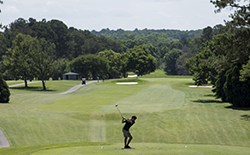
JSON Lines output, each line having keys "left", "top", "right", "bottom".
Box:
{"left": 103, "top": 84, "right": 185, "bottom": 114}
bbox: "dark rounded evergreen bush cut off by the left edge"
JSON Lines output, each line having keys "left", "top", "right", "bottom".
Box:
{"left": 0, "top": 73, "right": 10, "bottom": 103}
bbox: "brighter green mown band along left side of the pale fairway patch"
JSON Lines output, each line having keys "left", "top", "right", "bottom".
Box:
{"left": 40, "top": 84, "right": 145, "bottom": 112}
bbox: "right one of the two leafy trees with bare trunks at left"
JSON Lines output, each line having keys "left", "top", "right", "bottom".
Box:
{"left": 32, "top": 38, "right": 59, "bottom": 90}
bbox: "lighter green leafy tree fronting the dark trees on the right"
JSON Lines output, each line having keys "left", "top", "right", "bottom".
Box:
{"left": 185, "top": 34, "right": 230, "bottom": 85}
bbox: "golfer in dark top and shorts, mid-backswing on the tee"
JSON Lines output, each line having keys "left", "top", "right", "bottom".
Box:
{"left": 122, "top": 116, "right": 137, "bottom": 149}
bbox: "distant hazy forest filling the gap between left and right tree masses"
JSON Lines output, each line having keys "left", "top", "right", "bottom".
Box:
{"left": 92, "top": 24, "right": 231, "bottom": 75}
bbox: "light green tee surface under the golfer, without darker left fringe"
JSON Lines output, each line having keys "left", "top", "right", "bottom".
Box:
{"left": 31, "top": 143, "right": 250, "bottom": 155}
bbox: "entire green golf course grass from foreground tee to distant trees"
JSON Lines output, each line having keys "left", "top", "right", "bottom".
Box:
{"left": 0, "top": 75, "right": 250, "bottom": 155}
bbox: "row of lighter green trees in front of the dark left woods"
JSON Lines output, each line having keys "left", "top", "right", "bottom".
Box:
{"left": 2, "top": 33, "right": 156, "bottom": 90}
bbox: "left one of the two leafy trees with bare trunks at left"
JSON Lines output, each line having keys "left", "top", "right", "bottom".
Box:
{"left": 3, "top": 33, "right": 39, "bottom": 88}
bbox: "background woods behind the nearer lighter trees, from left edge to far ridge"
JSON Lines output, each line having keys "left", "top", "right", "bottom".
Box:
{"left": 0, "top": 18, "right": 228, "bottom": 81}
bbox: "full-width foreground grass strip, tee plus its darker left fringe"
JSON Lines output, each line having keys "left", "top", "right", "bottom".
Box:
{"left": 0, "top": 142, "right": 250, "bottom": 155}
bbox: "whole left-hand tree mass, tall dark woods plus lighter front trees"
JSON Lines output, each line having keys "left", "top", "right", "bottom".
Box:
{"left": 0, "top": 18, "right": 156, "bottom": 90}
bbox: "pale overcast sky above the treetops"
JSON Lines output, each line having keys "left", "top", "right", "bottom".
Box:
{"left": 0, "top": 0, "right": 230, "bottom": 31}
